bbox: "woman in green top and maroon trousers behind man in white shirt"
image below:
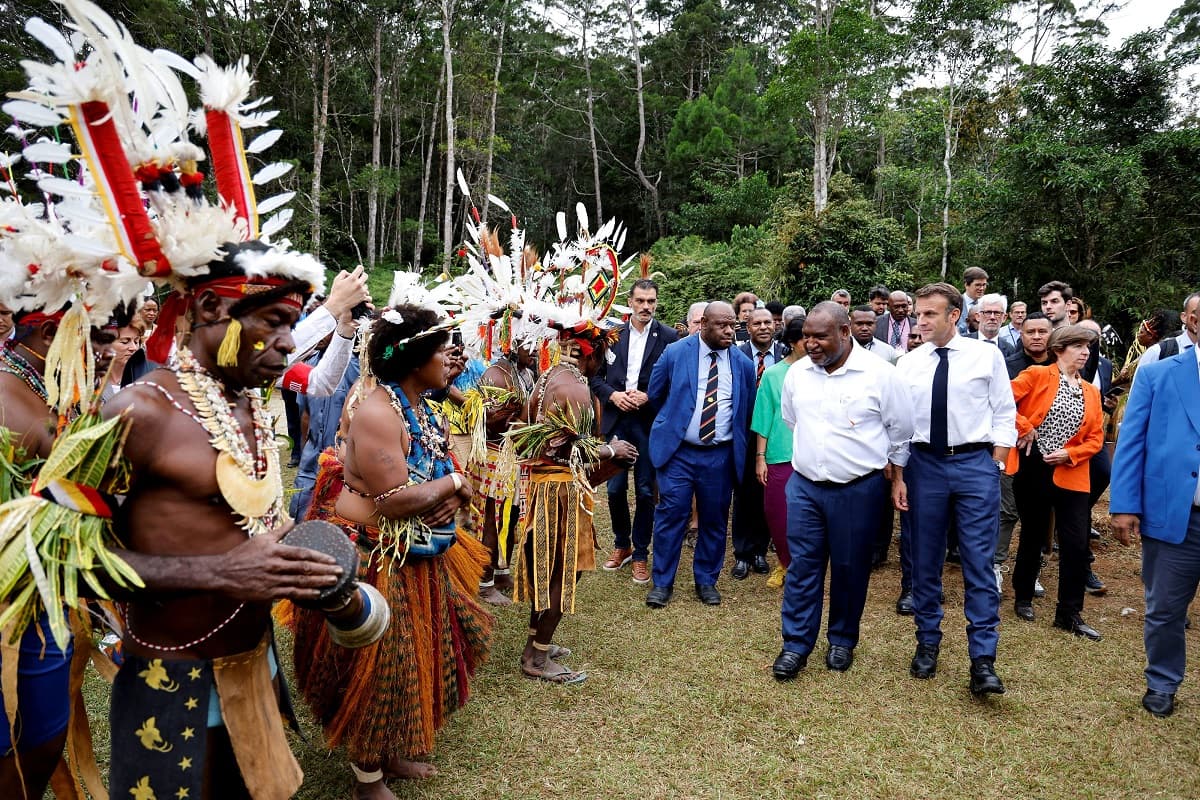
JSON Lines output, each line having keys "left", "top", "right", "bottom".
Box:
{"left": 750, "top": 317, "right": 804, "bottom": 589}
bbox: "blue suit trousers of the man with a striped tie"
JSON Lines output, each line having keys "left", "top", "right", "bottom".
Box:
{"left": 638, "top": 443, "right": 740, "bottom": 587}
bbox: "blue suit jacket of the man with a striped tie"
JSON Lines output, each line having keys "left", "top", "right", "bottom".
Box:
{"left": 648, "top": 336, "right": 755, "bottom": 481}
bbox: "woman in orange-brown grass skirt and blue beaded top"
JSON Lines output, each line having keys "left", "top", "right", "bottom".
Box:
{"left": 295, "top": 305, "right": 492, "bottom": 799}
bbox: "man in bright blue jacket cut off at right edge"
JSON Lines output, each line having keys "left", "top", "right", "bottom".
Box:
{"left": 1109, "top": 335, "right": 1200, "bottom": 717}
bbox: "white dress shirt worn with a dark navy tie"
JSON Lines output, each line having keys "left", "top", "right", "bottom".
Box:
{"left": 893, "top": 335, "right": 1016, "bottom": 467}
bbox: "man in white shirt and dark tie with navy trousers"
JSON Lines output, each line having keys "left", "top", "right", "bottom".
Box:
{"left": 892, "top": 283, "right": 1016, "bottom": 696}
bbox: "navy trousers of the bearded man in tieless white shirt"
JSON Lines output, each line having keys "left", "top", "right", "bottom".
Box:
{"left": 782, "top": 473, "right": 890, "bottom": 655}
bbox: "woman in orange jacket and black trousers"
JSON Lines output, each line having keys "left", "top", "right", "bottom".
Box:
{"left": 1008, "top": 325, "right": 1104, "bottom": 642}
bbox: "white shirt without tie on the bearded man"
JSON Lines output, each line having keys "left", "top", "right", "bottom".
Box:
{"left": 780, "top": 342, "right": 913, "bottom": 483}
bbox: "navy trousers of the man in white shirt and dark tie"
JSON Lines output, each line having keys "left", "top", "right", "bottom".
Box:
{"left": 904, "top": 447, "right": 1000, "bottom": 658}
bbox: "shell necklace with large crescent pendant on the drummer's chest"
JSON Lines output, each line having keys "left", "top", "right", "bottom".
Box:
{"left": 176, "top": 348, "right": 286, "bottom": 536}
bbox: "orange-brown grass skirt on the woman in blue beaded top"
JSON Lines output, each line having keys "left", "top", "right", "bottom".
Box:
{"left": 293, "top": 451, "right": 493, "bottom": 765}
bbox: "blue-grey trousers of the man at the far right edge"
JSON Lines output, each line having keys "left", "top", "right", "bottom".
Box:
{"left": 1141, "top": 509, "right": 1200, "bottom": 694}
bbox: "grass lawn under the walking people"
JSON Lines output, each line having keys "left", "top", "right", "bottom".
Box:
{"left": 75, "top": 489, "right": 1200, "bottom": 800}
